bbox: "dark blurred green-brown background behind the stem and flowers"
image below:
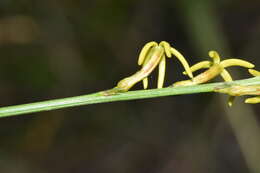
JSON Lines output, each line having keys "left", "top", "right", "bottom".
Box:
{"left": 0, "top": 0, "right": 260, "bottom": 173}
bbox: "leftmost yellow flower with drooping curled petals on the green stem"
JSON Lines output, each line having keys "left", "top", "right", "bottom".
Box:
{"left": 110, "top": 41, "right": 193, "bottom": 92}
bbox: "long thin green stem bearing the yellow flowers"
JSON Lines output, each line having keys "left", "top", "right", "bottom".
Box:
{"left": 0, "top": 77, "right": 260, "bottom": 118}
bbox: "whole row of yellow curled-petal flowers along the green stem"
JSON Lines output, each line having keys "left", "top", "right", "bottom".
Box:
{"left": 105, "top": 41, "right": 260, "bottom": 106}
